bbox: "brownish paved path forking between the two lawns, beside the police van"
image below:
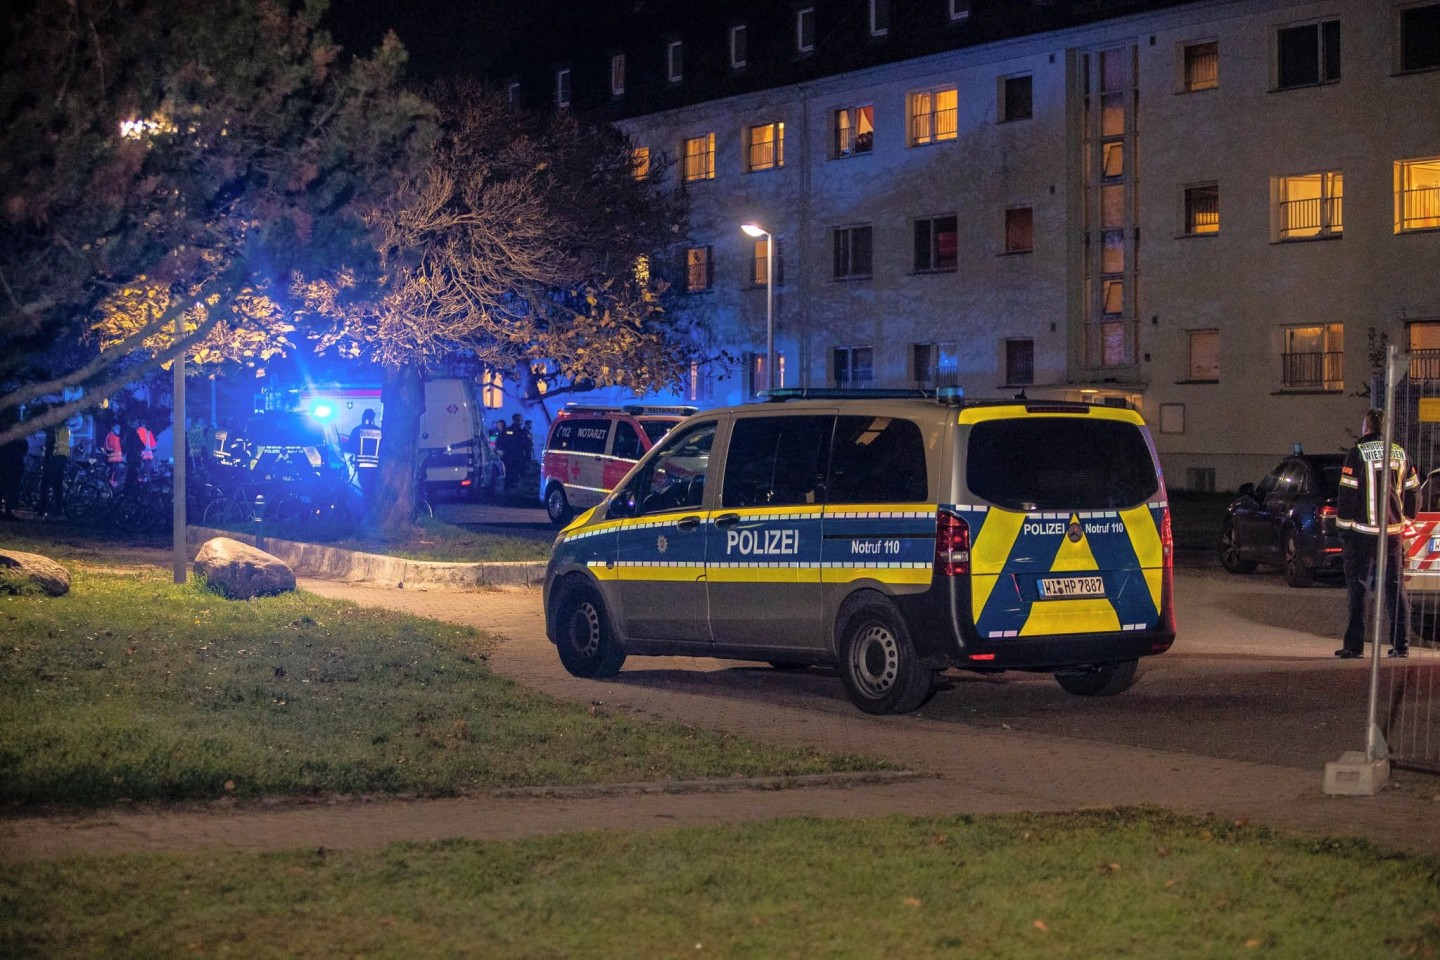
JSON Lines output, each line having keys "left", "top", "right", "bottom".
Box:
{"left": 0, "top": 580, "right": 1440, "bottom": 861}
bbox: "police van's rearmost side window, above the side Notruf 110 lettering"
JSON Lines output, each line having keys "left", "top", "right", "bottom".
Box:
{"left": 827, "top": 416, "right": 929, "bottom": 504}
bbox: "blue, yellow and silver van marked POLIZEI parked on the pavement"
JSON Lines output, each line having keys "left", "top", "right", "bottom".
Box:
{"left": 544, "top": 389, "right": 1175, "bottom": 714}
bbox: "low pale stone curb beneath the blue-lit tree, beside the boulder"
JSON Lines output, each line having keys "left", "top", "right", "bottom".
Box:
{"left": 186, "top": 525, "right": 546, "bottom": 587}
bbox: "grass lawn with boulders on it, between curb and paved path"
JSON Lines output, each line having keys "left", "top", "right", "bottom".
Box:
{"left": 0, "top": 567, "right": 887, "bottom": 807}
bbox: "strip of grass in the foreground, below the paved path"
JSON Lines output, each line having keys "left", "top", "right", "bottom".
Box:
{"left": 0, "top": 810, "right": 1440, "bottom": 960}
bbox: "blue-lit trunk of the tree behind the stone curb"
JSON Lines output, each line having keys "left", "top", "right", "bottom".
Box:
{"left": 366, "top": 363, "right": 425, "bottom": 537}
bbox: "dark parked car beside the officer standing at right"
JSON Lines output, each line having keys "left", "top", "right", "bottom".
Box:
{"left": 1220, "top": 453, "right": 1345, "bottom": 587}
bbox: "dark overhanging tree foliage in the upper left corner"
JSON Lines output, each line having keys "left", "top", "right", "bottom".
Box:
{"left": 0, "top": 0, "right": 432, "bottom": 440}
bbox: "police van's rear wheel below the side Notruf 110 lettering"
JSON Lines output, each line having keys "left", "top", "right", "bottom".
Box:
{"left": 838, "top": 600, "right": 935, "bottom": 714}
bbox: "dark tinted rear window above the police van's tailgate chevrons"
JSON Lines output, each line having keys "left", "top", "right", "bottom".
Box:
{"left": 965, "top": 417, "right": 1159, "bottom": 510}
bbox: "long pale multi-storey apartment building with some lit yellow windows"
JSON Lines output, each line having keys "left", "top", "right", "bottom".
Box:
{"left": 492, "top": 0, "right": 1440, "bottom": 489}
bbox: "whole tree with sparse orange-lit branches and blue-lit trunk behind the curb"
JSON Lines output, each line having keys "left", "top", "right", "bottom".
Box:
{"left": 295, "top": 83, "right": 694, "bottom": 533}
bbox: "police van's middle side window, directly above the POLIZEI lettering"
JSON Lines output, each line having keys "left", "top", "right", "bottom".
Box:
{"left": 720, "top": 416, "right": 835, "bottom": 507}
